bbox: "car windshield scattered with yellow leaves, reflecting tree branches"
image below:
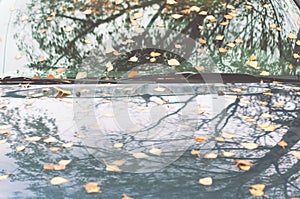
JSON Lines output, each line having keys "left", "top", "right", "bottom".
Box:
{"left": 0, "top": 0, "right": 300, "bottom": 78}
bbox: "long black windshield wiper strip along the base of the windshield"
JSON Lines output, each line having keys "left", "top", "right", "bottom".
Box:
{"left": 0, "top": 72, "right": 300, "bottom": 85}
